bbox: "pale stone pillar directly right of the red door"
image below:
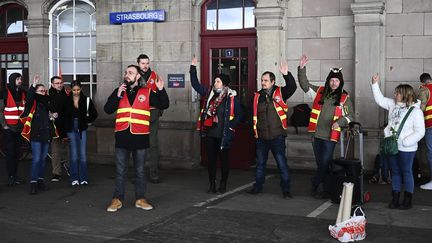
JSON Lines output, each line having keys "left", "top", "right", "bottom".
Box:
{"left": 254, "top": 0, "right": 286, "bottom": 90}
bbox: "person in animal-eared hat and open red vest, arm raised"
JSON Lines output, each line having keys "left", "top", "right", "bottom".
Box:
{"left": 298, "top": 55, "right": 354, "bottom": 198}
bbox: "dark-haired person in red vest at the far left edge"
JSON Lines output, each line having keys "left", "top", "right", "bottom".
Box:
{"left": 0, "top": 73, "right": 26, "bottom": 186}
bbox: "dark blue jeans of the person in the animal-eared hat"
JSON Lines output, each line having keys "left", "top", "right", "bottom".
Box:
{"left": 312, "top": 137, "right": 336, "bottom": 189}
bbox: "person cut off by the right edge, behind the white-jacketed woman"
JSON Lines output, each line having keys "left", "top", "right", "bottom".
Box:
{"left": 419, "top": 73, "right": 432, "bottom": 190}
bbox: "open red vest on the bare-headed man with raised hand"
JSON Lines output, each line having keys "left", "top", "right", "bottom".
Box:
{"left": 253, "top": 87, "right": 288, "bottom": 138}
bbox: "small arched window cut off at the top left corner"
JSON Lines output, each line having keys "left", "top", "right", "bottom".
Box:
{"left": 0, "top": 3, "right": 27, "bottom": 38}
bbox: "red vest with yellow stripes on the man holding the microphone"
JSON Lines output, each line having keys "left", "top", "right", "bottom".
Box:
{"left": 115, "top": 88, "right": 151, "bottom": 134}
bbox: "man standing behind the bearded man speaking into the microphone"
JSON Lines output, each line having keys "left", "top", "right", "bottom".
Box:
{"left": 137, "top": 54, "right": 162, "bottom": 184}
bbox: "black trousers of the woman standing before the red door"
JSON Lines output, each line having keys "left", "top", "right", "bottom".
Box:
{"left": 205, "top": 137, "right": 229, "bottom": 182}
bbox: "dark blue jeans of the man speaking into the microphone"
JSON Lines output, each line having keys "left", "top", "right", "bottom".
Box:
{"left": 113, "top": 148, "right": 146, "bottom": 200}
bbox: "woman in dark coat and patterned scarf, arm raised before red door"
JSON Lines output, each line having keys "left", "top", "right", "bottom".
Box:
{"left": 189, "top": 57, "right": 243, "bottom": 193}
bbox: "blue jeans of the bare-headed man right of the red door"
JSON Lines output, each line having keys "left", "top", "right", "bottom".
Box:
{"left": 254, "top": 136, "right": 291, "bottom": 192}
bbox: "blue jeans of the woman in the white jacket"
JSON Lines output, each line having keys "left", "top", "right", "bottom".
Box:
{"left": 388, "top": 151, "right": 416, "bottom": 193}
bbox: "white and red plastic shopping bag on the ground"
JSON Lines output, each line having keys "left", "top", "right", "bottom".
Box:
{"left": 329, "top": 207, "right": 366, "bottom": 242}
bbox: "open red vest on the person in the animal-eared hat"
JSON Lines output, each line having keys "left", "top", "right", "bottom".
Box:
{"left": 308, "top": 86, "right": 348, "bottom": 142}
